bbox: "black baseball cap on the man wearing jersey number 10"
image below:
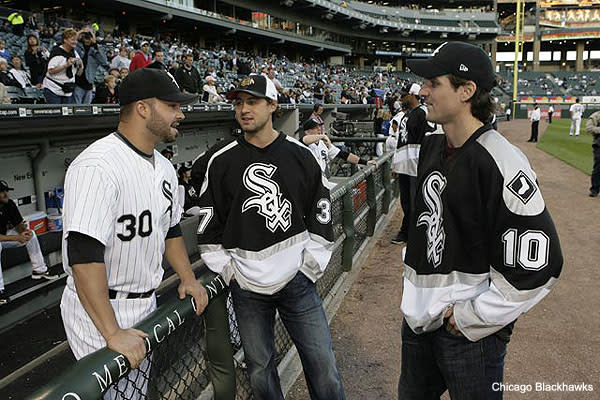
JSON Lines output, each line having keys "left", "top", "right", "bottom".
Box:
{"left": 406, "top": 42, "right": 496, "bottom": 91}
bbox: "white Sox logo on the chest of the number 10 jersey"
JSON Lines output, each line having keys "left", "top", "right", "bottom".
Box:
{"left": 417, "top": 171, "right": 446, "bottom": 268}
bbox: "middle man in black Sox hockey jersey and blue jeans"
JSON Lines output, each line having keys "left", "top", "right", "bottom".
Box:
{"left": 192, "top": 75, "right": 344, "bottom": 400}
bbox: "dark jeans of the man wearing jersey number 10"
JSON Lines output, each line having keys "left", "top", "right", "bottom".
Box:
{"left": 398, "top": 321, "right": 506, "bottom": 400}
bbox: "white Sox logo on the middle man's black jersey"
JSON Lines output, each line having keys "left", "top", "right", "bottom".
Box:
{"left": 242, "top": 163, "right": 292, "bottom": 232}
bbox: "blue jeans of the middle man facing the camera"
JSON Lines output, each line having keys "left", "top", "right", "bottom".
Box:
{"left": 230, "top": 272, "right": 345, "bottom": 400}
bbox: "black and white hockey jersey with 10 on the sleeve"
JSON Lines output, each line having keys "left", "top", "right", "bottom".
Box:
{"left": 402, "top": 125, "right": 563, "bottom": 341}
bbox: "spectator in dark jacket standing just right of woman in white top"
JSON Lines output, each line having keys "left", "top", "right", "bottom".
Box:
{"left": 73, "top": 26, "right": 108, "bottom": 104}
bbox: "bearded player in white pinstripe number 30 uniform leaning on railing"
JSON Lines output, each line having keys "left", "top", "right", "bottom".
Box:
{"left": 61, "top": 68, "right": 208, "bottom": 397}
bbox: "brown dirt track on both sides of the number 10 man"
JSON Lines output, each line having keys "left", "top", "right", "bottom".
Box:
{"left": 287, "top": 120, "right": 600, "bottom": 400}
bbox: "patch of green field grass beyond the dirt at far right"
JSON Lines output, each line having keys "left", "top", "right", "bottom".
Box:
{"left": 538, "top": 119, "right": 593, "bottom": 175}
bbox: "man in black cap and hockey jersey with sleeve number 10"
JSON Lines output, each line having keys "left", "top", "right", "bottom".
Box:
{"left": 398, "top": 42, "right": 563, "bottom": 400}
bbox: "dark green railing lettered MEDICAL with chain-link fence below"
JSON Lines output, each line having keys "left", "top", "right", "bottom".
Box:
{"left": 31, "top": 153, "right": 399, "bottom": 400}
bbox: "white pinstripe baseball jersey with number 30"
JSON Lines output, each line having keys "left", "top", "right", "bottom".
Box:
{"left": 62, "top": 133, "right": 182, "bottom": 293}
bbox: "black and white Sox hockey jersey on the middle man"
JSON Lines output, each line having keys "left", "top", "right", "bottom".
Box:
{"left": 192, "top": 133, "right": 333, "bottom": 294}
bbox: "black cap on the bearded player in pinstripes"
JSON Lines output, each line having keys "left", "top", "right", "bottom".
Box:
{"left": 119, "top": 68, "right": 198, "bottom": 106}
